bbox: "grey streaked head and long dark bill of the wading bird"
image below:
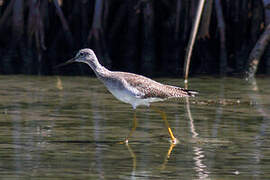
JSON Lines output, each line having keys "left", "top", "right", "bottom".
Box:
{"left": 56, "top": 48, "right": 98, "bottom": 68}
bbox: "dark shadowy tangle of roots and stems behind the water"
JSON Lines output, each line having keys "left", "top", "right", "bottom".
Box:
{"left": 0, "top": 0, "right": 270, "bottom": 77}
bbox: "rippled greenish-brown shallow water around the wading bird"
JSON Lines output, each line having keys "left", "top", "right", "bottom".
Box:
{"left": 0, "top": 76, "right": 270, "bottom": 179}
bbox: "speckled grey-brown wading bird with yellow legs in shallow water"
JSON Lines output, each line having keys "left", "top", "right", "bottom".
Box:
{"left": 56, "top": 48, "right": 198, "bottom": 143}
